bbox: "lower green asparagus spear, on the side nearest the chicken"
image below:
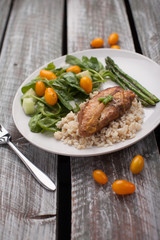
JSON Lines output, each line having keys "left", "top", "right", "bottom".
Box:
{"left": 106, "top": 62, "right": 155, "bottom": 106}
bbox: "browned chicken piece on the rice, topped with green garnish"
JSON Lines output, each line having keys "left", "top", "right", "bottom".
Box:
{"left": 78, "top": 87, "right": 135, "bottom": 137}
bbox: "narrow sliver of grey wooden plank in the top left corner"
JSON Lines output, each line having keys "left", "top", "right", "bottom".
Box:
{"left": 0, "top": 0, "right": 12, "bottom": 44}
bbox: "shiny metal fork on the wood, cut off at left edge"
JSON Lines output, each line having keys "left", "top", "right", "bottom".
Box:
{"left": 0, "top": 124, "right": 56, "bottom": 191}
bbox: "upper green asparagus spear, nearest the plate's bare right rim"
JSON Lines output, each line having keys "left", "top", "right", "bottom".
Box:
{"left": 107, "top": 57, "right": 159, "bottom": 103}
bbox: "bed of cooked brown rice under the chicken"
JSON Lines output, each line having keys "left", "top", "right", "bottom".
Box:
{"left": 54, "top": 92, "right": 144, "bottom": 149}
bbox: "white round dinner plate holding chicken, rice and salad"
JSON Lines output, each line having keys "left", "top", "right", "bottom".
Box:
{"left": 12, "top": 48, "right": 160, "bottom": 157}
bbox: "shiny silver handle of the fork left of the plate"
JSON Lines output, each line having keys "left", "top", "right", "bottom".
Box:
{"left": 7, "top": 141, "right": 56, "bottom": 191}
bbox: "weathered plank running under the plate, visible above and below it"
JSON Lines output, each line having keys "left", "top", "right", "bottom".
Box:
{"left": 68, "top": 0, "right": 160, "bottom": 240}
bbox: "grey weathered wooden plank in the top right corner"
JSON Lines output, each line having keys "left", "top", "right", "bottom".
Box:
{"left": 129, "top": 0, "right": 160, "bottom": 64}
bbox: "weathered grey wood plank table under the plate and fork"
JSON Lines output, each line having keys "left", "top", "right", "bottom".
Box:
{"left": 0, "top": 0, "right": 160, "bottom": 240}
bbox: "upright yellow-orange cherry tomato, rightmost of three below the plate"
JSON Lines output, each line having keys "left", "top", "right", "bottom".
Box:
{"left": 130, "top": 155, "right": 144, "bottom": 174}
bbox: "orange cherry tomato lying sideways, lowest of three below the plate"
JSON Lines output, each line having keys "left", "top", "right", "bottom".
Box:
{"left": 112, "top": 180, "right": 135, "bottom": 195}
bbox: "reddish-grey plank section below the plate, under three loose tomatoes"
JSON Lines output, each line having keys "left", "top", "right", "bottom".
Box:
{"left": 72, "top": 138, "right": 160, "bottom": 240}
